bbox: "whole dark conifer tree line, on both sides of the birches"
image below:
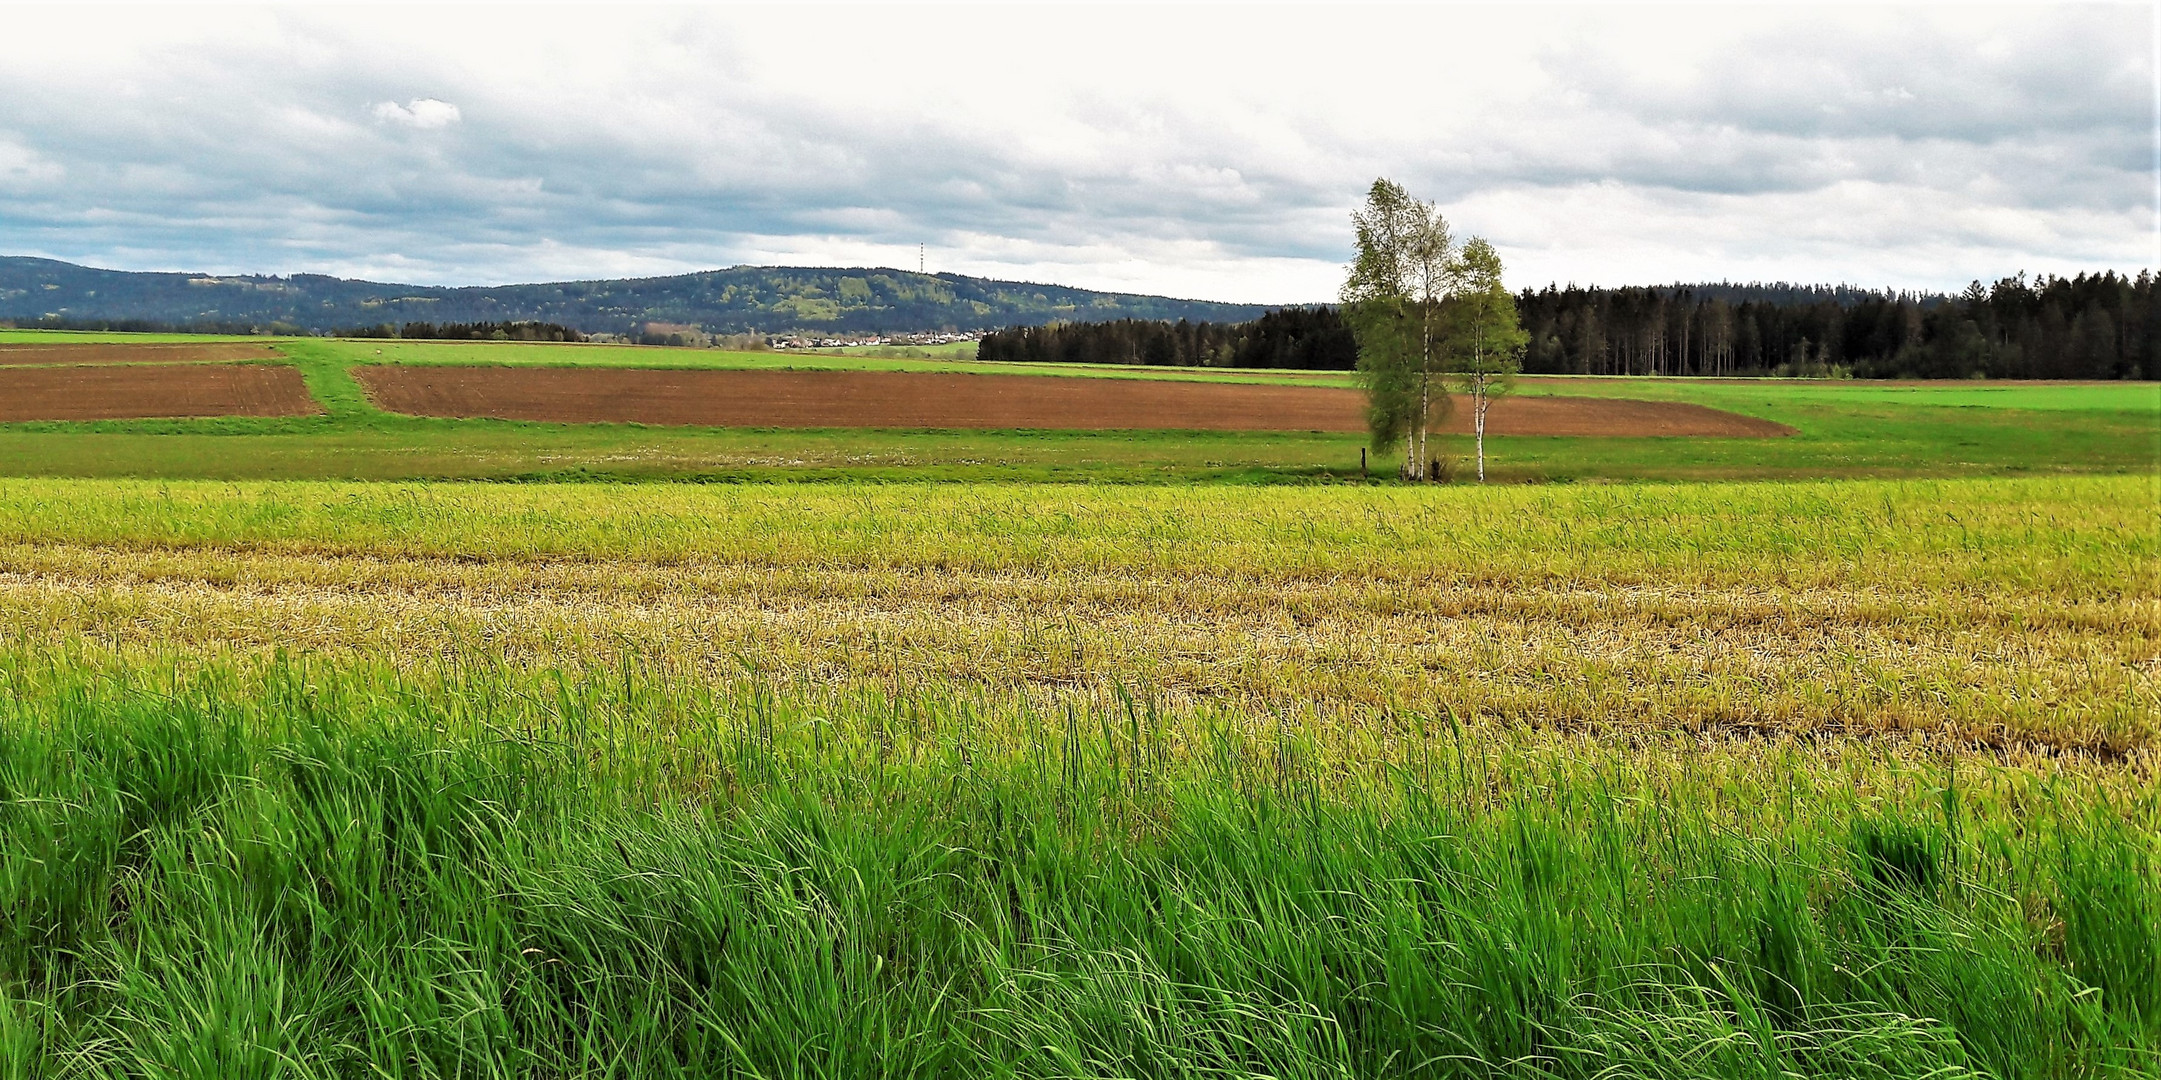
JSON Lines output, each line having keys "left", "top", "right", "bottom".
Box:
{"left": 979, "top": 272, "right": 2161, "bottom": 380}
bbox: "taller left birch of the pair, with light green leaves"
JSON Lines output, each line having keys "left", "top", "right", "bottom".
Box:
{"left": 1342, "top": 179, "right": 1454, "bottom": 480}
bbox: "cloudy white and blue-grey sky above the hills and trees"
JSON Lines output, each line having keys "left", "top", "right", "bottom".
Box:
{"left": 0, "top": 4, "right": 2161, "bottom": 302}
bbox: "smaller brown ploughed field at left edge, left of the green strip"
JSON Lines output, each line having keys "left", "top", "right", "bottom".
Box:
{"left": 0, "top": 363, "right": 322, "bottom": 421}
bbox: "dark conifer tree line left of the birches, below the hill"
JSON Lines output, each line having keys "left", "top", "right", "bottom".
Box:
{"left": 975, "top": 307, "right": 1357, "bottom": 372}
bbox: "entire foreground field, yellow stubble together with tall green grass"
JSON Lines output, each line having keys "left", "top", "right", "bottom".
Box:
{"left": 0, "top": 475, "right": 2161, "bottom": 1078}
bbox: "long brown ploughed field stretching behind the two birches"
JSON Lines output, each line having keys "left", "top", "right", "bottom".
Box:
{"left": 352, "top": 365, "right": 1794, "bottom": 436}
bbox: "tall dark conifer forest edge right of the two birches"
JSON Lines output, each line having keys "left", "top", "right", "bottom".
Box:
{"left": 1517, "top": 270, "right": 2161, "bottom": 378}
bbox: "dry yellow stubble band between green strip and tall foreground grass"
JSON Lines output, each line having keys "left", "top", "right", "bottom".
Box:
{"left": 0, "top": 527, "right": 2161, "bottom": 758}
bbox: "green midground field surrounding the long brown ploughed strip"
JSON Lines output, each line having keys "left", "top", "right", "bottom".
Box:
{"left": 0, "top": 330, "right": 2161, "bottom": 482}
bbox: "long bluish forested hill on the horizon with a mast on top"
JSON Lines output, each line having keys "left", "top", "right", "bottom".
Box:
{"left": 0, "top": 257, "right": 1266, "bottom": 335}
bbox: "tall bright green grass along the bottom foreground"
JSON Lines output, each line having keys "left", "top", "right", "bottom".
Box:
{"left": 0, "top": 648, "right": 2161, "bottom": 1078}
